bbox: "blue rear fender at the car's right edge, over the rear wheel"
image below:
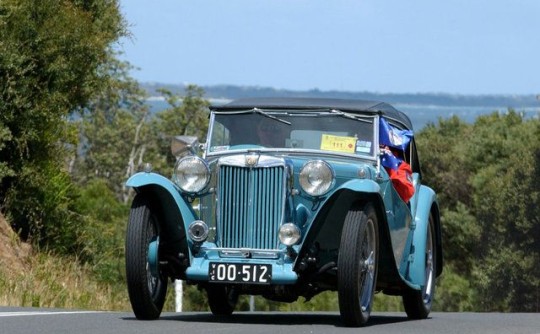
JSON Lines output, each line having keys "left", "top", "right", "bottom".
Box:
{"left": 407, "top": 186, "right": 437, "bottom": 286}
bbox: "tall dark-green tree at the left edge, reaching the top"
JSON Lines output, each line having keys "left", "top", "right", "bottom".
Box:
{"left": 0, "top": 0, "right": 125, "bottom": 251}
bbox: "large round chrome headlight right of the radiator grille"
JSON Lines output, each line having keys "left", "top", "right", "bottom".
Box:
{"left": 299, "top": 160, "right": 334, "bottom": 196}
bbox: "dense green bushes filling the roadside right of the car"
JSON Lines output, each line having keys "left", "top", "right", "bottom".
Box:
{"left": 417, "top": 110, "right": 540, "bottom": 312}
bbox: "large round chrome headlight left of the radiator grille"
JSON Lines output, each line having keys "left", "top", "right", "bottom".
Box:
{"left": 173, "top": 156, "right": 210, "bottom": 194}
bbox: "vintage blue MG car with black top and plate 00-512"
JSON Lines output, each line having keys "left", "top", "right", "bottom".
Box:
{"left": 126, "top": 98, "right": 443, "bottom": 326}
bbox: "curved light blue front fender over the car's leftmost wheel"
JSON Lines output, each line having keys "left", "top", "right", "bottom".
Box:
{"left": 126, "top": 172, "right": 198, "bottom": 262}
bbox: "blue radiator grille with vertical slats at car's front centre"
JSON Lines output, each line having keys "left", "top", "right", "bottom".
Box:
{"left": 217, "top": 166, "right": 285, "bottom": 249}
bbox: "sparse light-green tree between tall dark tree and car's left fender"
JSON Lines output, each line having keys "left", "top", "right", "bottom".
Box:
{"left": 72, "top": 59, "right": 153, "bottom": 203}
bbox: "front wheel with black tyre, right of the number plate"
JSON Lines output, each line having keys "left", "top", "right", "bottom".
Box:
{"left": 338, "top": 204, "right": 379, "bottom": 327}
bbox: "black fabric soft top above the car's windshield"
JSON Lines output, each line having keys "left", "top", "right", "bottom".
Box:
{"left": 210, "top": 98, "right": 413, "bottom": 130}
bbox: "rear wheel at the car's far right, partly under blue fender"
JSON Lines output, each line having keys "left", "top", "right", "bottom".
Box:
{"left": 403, "top": 215, "right": 437, "bottom": 319}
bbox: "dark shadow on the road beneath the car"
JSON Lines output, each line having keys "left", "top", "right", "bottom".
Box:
{"left": 148, "top": 312, "right": 408, "bottom": 327}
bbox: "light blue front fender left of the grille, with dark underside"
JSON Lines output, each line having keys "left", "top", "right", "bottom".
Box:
{"left": 126, "top": 172, "right": 198, "bottom": 262}
